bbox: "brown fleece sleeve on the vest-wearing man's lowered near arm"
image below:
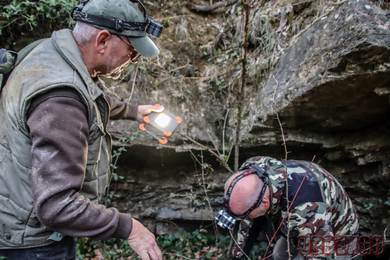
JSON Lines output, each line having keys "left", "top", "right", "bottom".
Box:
{"left": 27, "top": 91, "right": 132, "bottom": 239}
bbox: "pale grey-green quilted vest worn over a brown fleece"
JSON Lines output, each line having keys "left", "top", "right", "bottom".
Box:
{"left": 0, "top": 30, "right": 111, "bottom": 249}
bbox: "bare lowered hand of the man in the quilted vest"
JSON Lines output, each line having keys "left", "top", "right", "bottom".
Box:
{"left": 127, "top": 219, "right": 162, "bottom": 260}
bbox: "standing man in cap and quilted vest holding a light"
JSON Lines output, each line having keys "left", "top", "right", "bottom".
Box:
{"left": 0, "top": 0, "right": 162, "bottom": 260}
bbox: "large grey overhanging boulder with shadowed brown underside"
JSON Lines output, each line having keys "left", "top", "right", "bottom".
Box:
{"left": 251, "top": 1, "right": 390, "bottom": 132}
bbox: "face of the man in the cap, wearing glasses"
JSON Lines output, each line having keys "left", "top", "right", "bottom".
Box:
{"left": 105, "top": 34, "right": 139, "bottom": 79}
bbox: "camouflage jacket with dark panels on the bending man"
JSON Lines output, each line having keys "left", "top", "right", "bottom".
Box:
{"left": 232, "top": 156, "right": 359, "bottom": 259}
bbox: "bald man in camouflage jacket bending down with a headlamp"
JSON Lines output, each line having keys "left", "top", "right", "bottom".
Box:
{"left": 216, "top": 156, "right": 359, "bottom": 260}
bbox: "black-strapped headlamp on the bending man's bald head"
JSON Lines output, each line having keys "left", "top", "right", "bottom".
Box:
{"left": 214, "top": 165, "right": 268, "bottom": 229}
